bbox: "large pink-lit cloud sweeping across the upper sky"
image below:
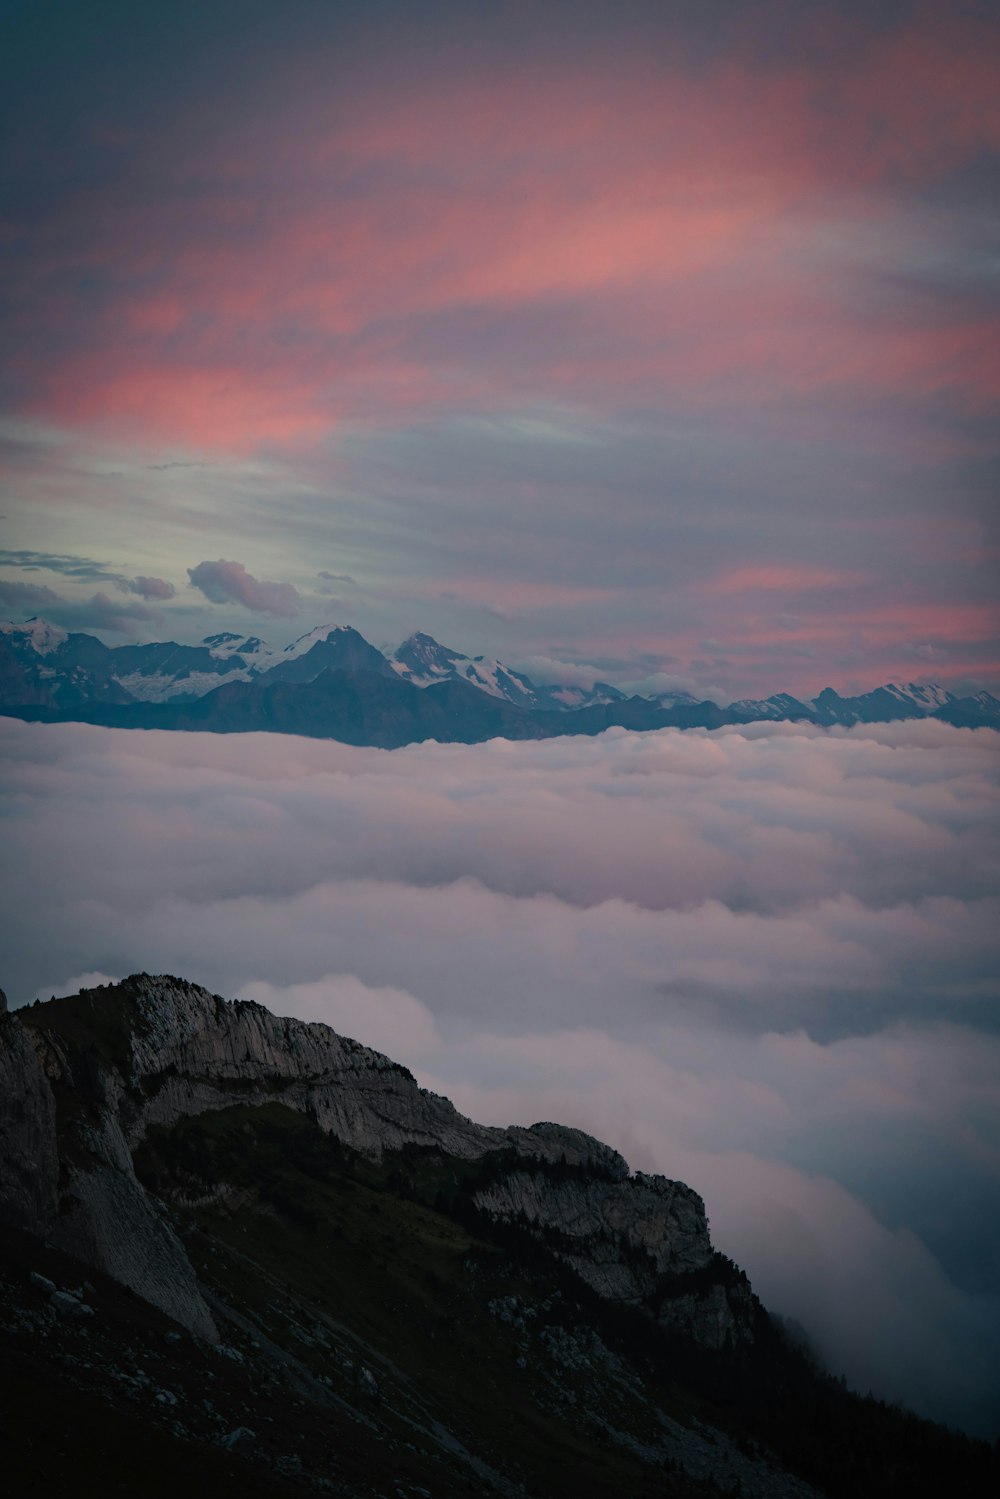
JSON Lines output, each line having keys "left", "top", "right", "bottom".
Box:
{"left": 9, "top": 9, "right": 1000, "bottom": 451}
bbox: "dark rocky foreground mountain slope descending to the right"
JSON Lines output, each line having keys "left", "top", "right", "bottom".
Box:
{"left": 0, "top": 974, "right": 999, "bottom": 1499}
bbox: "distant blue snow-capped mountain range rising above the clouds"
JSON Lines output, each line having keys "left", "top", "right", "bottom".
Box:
{"left": 0, "top": 619, "right": 1000, "bottom": 748}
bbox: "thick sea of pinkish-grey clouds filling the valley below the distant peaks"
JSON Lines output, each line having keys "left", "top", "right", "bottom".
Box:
{"left": 0, "top": 720, "right": 1000, "bottom": 1433}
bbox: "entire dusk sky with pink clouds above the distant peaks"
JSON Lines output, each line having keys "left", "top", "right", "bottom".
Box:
{"left": 0, "top": 0, "right": 1000, "bottom": 696}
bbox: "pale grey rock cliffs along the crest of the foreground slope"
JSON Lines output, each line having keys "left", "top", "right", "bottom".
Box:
{"left": 0, "top": 974, "right": 753, "bottom": 1348}
